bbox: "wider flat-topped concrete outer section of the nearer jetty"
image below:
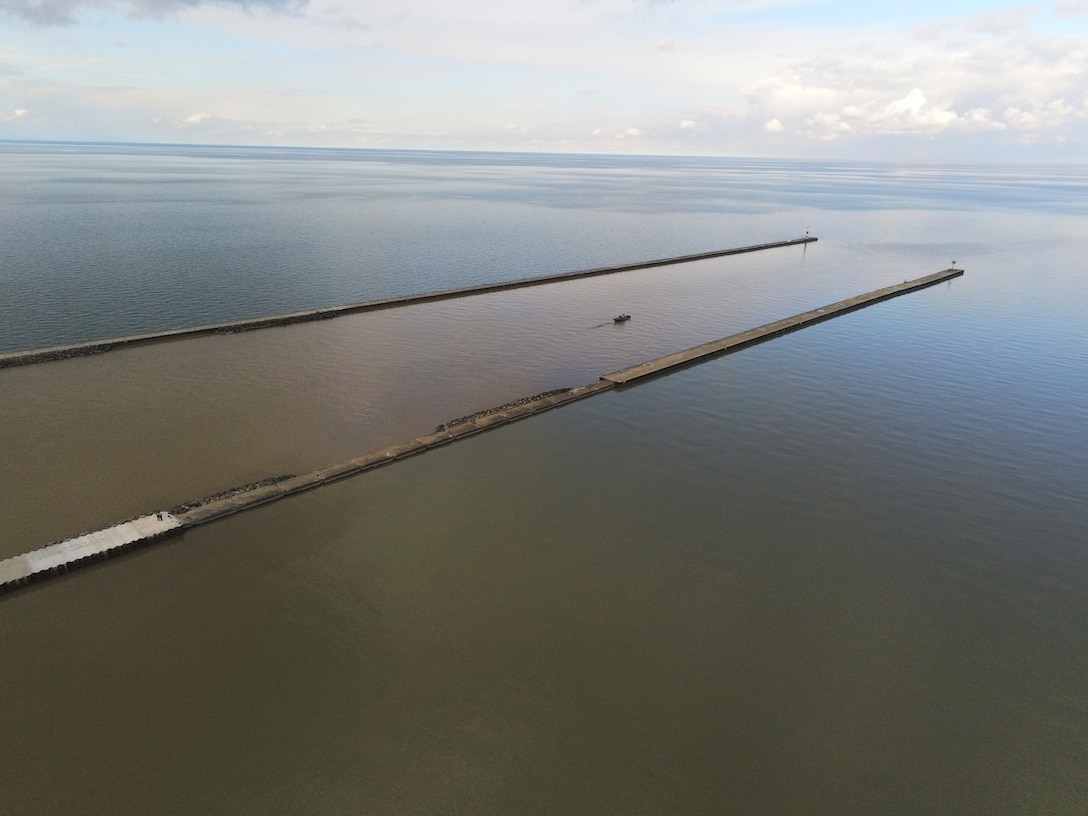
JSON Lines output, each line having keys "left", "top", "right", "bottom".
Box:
{"left": 602, "top": 269, "right": 963, "bottom": 385}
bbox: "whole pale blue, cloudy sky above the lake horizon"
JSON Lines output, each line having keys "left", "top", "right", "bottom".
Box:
{"left": 0, "top": 0, "right": 1088, "bottom": 162}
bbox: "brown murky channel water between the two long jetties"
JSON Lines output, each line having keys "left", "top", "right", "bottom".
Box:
{"left": 0, "top": 248, "right": 839, "bottom": 556}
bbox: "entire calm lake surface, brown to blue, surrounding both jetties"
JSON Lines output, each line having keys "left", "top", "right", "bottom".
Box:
{"left": 0, "top": 144, "right": 1088, "bottom": 814}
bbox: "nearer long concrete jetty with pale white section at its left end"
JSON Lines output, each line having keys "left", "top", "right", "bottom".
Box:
{"left": 0, "top": 269, "right": 963, "bottom": 592}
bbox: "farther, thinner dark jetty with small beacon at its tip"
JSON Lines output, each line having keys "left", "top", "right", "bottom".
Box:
{"left": 0, "top": 235, "right": 818, "bottom": 369}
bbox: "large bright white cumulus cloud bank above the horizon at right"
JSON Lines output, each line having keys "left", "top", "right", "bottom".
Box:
{"left": 743, "top": 10, "right": 1088, "bottom": 150}
